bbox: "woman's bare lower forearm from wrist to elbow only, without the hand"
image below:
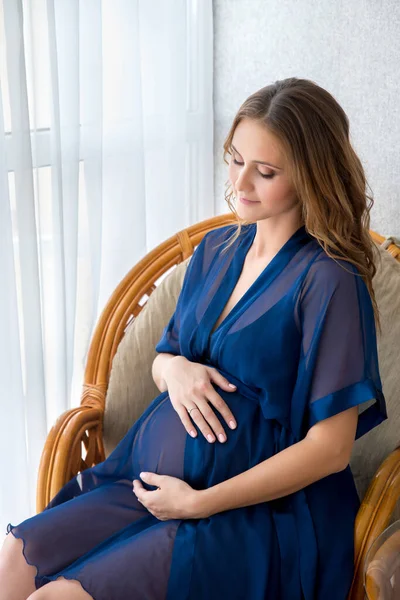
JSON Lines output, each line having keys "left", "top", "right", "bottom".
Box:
{"left": 193, "top": 438, "right": 347, "bottom": 518}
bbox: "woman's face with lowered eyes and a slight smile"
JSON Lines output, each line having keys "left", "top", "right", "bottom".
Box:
{"left": 229, "top": 118, "right": 299, "bottom": 221}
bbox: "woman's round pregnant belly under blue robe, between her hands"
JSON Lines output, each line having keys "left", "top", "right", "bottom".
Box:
{"left": 132, "top": 384, "right": 275, "bottom": 489}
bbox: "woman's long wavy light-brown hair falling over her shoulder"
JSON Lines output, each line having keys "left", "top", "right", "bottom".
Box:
{"left": 223, "top": 77, "right": 381, "bottom": 331}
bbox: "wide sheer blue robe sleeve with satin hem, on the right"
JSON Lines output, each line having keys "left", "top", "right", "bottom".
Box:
{"left": 300, "top": 255, "right": 387, "bottom": 439}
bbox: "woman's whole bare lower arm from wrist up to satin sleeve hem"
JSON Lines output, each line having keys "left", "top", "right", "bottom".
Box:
{"left": 193, "top": 406, "right": 358, "bottom": 518}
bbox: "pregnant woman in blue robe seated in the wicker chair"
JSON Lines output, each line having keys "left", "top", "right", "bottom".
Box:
{"left": 0, "top": 78, "right": 387, "bottom": 600}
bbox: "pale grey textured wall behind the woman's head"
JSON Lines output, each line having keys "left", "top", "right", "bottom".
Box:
{"left": 214, "top": 0, "right": 400, "bottom": 236}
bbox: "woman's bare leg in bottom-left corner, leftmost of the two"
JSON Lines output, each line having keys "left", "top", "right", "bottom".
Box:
{"left": 0, "top": 533, "right": 36, "bottom": 600}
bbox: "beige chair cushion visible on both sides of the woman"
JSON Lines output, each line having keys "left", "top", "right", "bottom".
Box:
{"left": 104, "top": 239, "right": 400, "bottom": 510}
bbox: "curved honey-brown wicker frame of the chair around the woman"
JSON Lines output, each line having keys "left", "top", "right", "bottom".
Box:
{"left": 37, "top": 213, "right": 400, "bottom": 600}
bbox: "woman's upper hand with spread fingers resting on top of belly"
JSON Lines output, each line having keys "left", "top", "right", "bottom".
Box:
{"left": 163, "top": 356, "right": 236, "bottom": 443}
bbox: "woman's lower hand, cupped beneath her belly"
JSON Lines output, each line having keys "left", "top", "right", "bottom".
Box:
{"left": 133, "top": 473, "right": 199, "bottom": 521}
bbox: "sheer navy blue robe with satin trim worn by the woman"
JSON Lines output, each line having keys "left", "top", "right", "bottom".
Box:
{"left": 8, "top": 224, "right": 387, "bottom": 600}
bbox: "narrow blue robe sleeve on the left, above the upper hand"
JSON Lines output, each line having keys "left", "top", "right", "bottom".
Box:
{"left": 155, "top": 231, "right": 212, "bottom": 355}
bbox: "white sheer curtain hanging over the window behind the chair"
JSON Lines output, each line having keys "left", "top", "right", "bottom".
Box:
{"left": 0, "top": 0, "right": 214, "bottom": 539}
